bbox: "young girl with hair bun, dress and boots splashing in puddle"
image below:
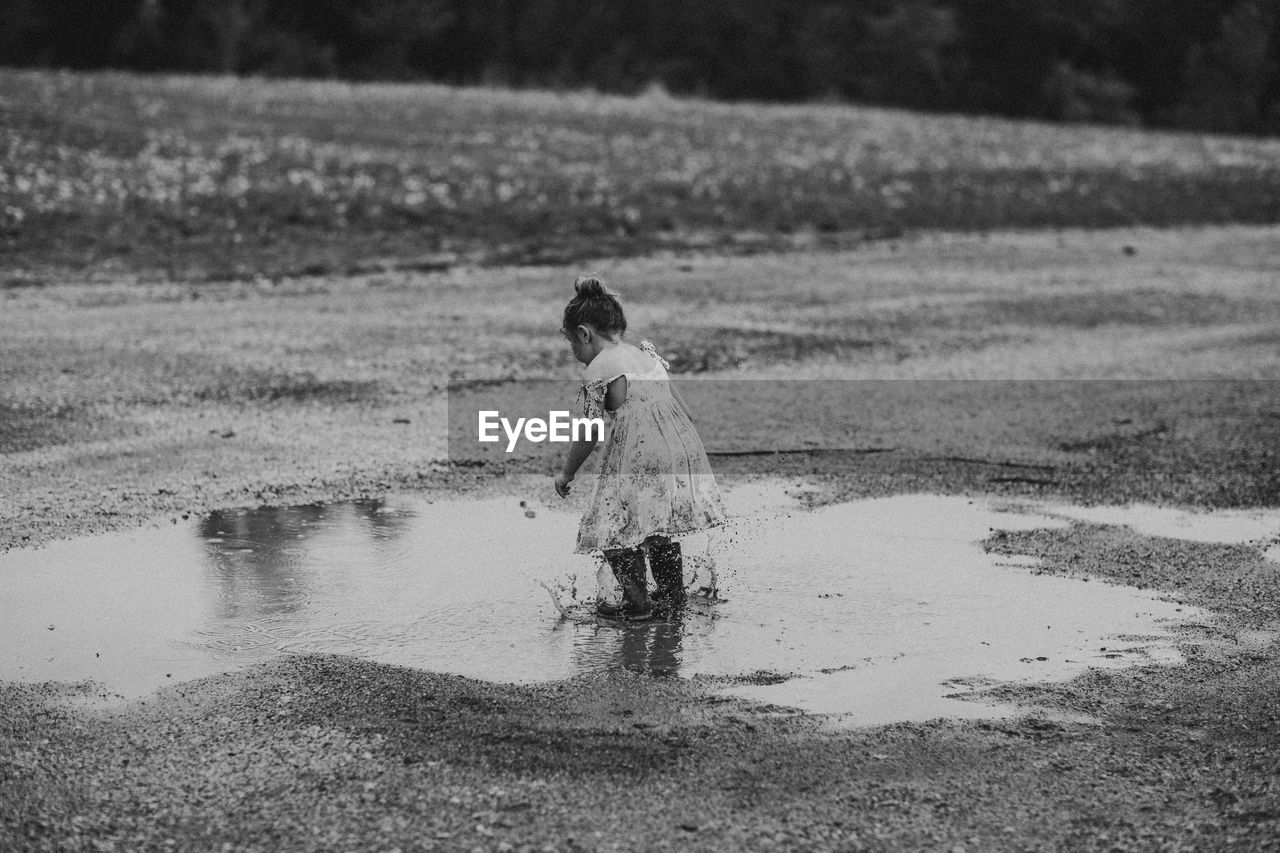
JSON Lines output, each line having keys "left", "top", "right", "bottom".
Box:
{"left": 556, "top": 275, "right": 724, "bottom": 620}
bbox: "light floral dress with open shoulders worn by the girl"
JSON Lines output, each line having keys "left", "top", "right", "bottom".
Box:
{"left": 575, "top": 341, "right": 724, "bottom": 553}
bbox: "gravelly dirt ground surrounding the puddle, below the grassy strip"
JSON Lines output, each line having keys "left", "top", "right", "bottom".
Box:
{"left": 0, "top": 227, "right": 1280, "bottom": 850}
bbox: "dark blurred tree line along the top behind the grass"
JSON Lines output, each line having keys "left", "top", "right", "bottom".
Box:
{"left": 0, "top": 0, "right": 1280, "bottom": 133}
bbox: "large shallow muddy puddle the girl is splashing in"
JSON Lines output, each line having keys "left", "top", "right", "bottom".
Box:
{"left": 0, "top": 483, "right": 1280, "bottom": 725}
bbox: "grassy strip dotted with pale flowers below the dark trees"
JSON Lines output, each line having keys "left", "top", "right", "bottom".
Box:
{"left": 0, "top": 70, "right": 1280, "bottom": 282}
